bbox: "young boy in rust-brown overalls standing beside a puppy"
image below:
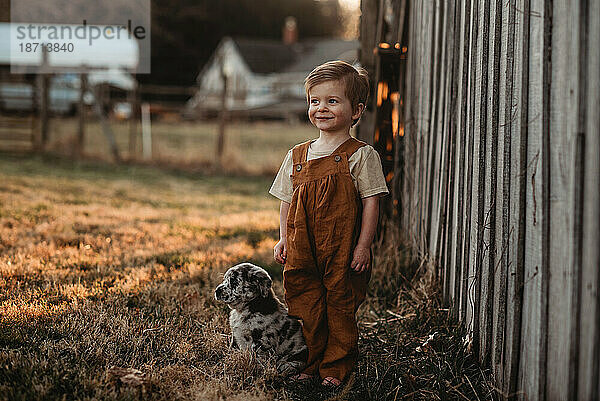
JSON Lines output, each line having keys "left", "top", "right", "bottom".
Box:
{"left": 269, "top": 61, "right": 389, "bottom": 386}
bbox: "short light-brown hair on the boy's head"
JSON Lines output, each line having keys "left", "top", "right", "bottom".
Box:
{"left": 304, "top": 60, "right": 369, "bottom": 126}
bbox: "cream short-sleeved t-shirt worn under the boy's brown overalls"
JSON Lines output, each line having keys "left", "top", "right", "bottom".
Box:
{"left": 269, "top": 143, "right": 389, "bottom": 203}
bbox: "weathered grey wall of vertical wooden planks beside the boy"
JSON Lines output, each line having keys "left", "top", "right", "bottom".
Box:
{"left": 363, "top": 0, "right": 600, "bottom": 400}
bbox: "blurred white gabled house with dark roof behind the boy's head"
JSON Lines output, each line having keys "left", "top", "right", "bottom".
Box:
{"left": 185, "top": 28, "right": 358, "bottom": 120}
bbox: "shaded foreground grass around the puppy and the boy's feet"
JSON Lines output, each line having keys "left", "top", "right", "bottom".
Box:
{"left": 0, "top": 231, "right": 494, "bottom": 401}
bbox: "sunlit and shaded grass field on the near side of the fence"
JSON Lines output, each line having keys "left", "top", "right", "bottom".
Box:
{"left": 0, "top": 152, "right": 494, "bottom": 400}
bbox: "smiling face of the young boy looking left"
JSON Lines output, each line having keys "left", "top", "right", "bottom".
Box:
{"left": 308, "top": 81, "right": 364, "bottom": 133}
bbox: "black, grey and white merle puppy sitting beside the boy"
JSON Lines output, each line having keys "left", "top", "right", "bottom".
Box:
{"left": 215, "top": 263, "right": 308, "bottom": 375}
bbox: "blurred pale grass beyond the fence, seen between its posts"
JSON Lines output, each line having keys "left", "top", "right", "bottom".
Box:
{"left": 48, "top": 117, "right": 319, "bottom": 174}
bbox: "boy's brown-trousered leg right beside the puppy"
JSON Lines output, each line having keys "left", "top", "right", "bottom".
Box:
{"left": 283, "top": 266, "right": 328, "bottom": 375}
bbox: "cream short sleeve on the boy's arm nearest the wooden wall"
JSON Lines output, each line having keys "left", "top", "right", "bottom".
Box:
{"left": 354, "top": 145, "right": 390, "bottom": 198}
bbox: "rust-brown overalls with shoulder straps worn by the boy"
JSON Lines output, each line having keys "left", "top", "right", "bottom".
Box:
{"left": 283, "top": 138, "right": 372, "bottom": 380}
